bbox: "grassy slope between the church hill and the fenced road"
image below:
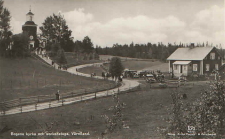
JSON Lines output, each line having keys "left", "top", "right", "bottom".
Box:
{"left": 0, "top": 58, "right": 113, "bottom": 101}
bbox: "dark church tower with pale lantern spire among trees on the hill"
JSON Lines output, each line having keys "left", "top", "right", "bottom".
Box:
{"left": 22, "top": 9, "right": 37, "bottom": 48}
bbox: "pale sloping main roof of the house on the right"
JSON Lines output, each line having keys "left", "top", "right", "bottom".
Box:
{"left": 167, "top": 47, "right": 214, "bottom": 60}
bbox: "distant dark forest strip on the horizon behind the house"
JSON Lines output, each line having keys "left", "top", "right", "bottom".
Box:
{"left": 96, "top": 42, "right": 224, "bottom": 61}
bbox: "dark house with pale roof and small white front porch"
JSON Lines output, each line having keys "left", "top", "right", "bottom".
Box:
{"left": 167, "top": 47, "right": 222, "bottom": 77}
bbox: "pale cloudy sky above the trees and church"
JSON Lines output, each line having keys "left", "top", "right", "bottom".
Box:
{"left": 4, "top": 0, "right": 225, "bottom": 48}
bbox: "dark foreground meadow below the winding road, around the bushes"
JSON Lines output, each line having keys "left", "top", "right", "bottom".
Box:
{"left": 0, "top": 82, "right": 206, "bottom": 139}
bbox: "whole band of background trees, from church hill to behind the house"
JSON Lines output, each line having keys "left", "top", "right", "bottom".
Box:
{"left": 0, "top": 0, "right": 224, "bottom": 61}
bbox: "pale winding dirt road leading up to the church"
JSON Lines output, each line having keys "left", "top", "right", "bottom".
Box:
{"left": 0, "top": 56, "right": 139, "bottom": 116}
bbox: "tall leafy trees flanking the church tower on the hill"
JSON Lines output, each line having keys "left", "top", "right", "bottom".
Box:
{"left": 0, "top": 0, "right": 94, "bottom": 64}
